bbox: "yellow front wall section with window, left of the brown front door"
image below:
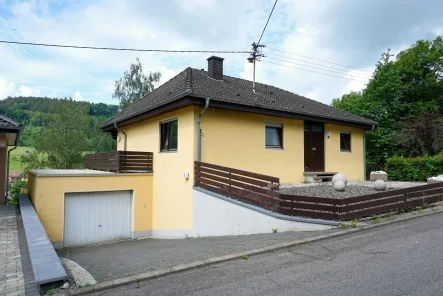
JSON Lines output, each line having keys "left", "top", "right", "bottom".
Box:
{"left": 201, "top": 107, "right": 304, "bottom": 183}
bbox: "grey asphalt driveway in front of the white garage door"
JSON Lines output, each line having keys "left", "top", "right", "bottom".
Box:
{"left": 57, "top": 229, "right": 337, "bottom": 282}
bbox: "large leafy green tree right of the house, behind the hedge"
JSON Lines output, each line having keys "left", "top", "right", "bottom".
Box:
{"left": 332, "top": 36, "right": 443, "bottom": 170}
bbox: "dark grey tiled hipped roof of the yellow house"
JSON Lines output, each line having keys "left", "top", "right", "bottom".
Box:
{"left": 103, "top": 68, "right": 376, "bottom": 127}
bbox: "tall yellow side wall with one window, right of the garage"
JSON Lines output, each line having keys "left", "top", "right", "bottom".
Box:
{"left": 117, "top": 106, "right": 196, "bottom": 230}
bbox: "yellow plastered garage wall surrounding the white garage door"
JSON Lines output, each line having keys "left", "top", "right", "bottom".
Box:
{"left": 28, "top": 174, "right": 152, "bottom": 242}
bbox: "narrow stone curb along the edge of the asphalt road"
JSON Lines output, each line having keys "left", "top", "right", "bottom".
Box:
{"left": 67, "top": 207, "right": 443, "bottom": 295}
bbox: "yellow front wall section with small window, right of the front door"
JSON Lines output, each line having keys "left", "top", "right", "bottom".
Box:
{"left": 325, "top": 124, "right": 365, "bottom": 180}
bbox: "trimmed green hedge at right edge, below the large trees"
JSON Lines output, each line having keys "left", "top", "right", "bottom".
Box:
{"left": 385, "top": 153, "right": 443, "bottom": 181}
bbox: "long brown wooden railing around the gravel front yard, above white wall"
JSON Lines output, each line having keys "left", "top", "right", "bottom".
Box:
{"left": 194, "top": 161, "right": 443, "bottom": 221}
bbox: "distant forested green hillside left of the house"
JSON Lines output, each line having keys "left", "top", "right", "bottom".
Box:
{"left": 0, "top": 97, "right": 119, "bottom": 151}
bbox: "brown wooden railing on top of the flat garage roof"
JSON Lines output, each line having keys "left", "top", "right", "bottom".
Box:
{"left": 85, "top": 151, "right": 153, "bottom": 173}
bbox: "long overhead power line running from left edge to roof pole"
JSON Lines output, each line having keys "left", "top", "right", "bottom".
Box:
{"left": 0, "top": 40, "right": 250, "bottom": 54}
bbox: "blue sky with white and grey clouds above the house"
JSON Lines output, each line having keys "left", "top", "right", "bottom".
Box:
{"left": 0, "top": 0, "right": 443, "bottom": 104}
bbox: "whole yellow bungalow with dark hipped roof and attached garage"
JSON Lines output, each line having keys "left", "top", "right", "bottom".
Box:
{"left": 28, "top": 56, "right": 375, "bottom": 247}
